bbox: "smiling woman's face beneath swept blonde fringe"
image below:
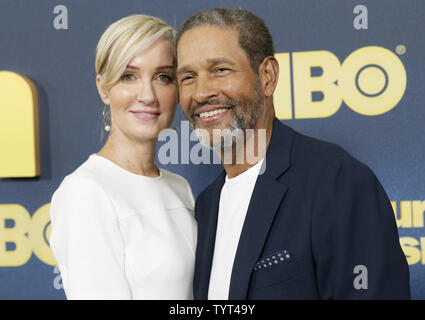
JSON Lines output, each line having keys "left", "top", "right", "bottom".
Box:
{"left": 98, "top": 38, "right": 177, "bottom": 140}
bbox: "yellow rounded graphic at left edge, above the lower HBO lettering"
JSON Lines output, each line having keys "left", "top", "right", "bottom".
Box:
{"left": 0, "top": 71, "right": 40, "bottom": 178}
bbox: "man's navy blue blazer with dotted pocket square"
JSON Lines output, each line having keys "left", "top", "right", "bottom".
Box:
{"left": 194, "top": 119, "right": 410, "bottom": 300}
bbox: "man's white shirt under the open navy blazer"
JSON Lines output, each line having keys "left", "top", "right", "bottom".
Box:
{"left": 208, "top": 159, "right": 264, "bottom": 300}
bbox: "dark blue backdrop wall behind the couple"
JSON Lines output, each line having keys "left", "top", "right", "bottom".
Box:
{"left": 0, "top": 0, "right": 425, "bottom": 299}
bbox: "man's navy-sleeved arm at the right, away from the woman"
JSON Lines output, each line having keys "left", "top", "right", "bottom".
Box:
{"left": 312, "top": 156, "right": 410, "bottom": 299}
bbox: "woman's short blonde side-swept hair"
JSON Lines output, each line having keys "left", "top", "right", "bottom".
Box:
{"left": 95, "top": 14, "right": 176, "bottom": 92}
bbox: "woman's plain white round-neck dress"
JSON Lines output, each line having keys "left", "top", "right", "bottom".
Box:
{"left": 50, "top": 154, "right": 196, "bottom": 299}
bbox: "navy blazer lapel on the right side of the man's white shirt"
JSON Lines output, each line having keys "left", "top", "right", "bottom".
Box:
{"left": 229, "top": 119, "right": 294, "bottom": 300}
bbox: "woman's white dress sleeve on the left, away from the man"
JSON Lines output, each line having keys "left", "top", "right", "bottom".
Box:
{"left": 50, "top": 177, "right": 132, "bottom": 299}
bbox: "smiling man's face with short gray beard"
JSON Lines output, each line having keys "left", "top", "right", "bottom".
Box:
{"left": 177, "top": 25, "right": 263, "bottom": 146}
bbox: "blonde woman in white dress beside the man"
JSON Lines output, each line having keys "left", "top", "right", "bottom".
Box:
{"left": 50, "top": 15, "right": 196, "bottom": 299}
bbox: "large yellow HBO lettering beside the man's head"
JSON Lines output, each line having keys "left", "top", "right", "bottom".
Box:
{"left": 274, "top": 46, "right": 407, "bottom": 119}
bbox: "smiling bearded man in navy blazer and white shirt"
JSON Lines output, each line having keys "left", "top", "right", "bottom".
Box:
{"left": 177, "top": 9, "right": 410, "bottom": 299}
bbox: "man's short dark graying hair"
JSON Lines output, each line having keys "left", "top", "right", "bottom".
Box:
{"left": 176, "top": 8, "right": 275, "bottom": 73}
